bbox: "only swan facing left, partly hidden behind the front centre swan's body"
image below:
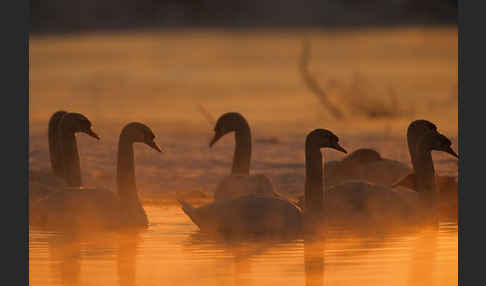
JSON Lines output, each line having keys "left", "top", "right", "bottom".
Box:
{"left": 209, "top": 112, "right": 279, "bottom": 201}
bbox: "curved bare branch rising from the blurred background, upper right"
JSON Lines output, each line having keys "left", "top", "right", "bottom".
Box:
{"left": 299, "top": 39, "right": 343, "bottom": 118}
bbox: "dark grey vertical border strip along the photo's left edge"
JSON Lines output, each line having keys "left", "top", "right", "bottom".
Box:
{"left": 0, "top": 0, "right": 30, "bottom": 285}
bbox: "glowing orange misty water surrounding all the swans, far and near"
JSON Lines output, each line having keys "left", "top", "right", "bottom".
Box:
{"left": 29, "top": 28, "right": 457, "bottom": 285}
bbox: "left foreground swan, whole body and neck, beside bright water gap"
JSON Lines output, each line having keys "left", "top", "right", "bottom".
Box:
{"left": 30, "top": 122, "right": 162, "bottom": 227}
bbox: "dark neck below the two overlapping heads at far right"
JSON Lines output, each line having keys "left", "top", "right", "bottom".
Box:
{"left": 410, "top": 139, "right": 436, "bottom": 197}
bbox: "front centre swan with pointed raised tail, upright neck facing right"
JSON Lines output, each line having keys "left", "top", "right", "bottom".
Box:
{"left": 179, "top": 129, "right": 346, "bottom": 235}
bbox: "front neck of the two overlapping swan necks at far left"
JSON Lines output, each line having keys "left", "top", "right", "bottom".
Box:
{"left": 56, "top": 128, "right": 82, "bottom": 187}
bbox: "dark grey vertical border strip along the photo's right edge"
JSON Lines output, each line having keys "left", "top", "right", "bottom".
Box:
{"left": 458, "top": 0, "right": 486, "bottom": 285}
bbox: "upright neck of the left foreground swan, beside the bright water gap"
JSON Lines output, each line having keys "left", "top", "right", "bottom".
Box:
{"left": 116, "top": 133, "right": 139, "bottom": 204}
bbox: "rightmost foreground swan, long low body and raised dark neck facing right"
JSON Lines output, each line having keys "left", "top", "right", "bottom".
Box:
{"left": 325, "top": 120, "right": 458, "bottom": 225}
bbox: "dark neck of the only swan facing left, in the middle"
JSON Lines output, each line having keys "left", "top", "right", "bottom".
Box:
{"left": 231, "top": 122, "right": 251, "bottom": 175}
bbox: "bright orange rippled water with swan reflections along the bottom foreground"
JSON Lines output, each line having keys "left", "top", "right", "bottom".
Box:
{"left": 29, "top": 207, "right": 457, "bottom": 286}
